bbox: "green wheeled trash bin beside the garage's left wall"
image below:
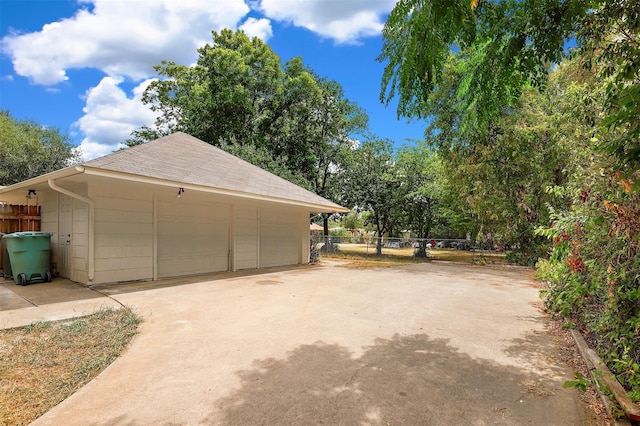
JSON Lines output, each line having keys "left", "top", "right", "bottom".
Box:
{"left": 2, "top": 232, "right": 52, "bottom": 285}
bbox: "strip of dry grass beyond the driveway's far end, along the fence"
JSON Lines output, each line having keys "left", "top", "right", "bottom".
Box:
{"left": 322, "top": 244, "right": 508, "bottom": 269}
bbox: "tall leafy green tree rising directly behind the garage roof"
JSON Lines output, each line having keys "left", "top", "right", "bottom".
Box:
{"left": 127, "top": 29, "right": 367, "bottom": 196}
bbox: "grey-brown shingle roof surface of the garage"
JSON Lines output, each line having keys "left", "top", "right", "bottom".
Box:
{"left": 83, "top": 132, "right": 345, "bottom": 211}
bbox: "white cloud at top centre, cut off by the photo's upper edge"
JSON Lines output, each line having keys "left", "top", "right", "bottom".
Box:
{"left": 251, "top": 0, "right": 396, "bottom": 43}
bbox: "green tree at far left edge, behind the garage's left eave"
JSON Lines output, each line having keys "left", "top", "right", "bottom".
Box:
{"left": 0, "top": 110, "right": 81, "bottom": 186}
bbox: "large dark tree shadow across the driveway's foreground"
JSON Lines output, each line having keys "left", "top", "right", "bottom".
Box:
{"left": 205, "top": 334, "right": 588, "bottom": 425}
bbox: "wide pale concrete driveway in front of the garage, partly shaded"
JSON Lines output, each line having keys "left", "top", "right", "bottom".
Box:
{"left": 27, "top": 262, "right": 589, "bottom": 425}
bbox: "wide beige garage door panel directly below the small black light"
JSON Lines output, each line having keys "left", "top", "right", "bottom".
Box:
{"left": 158, "top": 198, "right": 230, "bottom": 278}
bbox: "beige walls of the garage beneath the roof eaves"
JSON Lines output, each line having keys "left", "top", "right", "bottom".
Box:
{"left": 41, "top": 178, "right": 316, "bottom": 284}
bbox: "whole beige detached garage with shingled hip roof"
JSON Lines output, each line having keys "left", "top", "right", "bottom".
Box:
{"left": 0, "top": 132, "right": 348, "bottom": 284}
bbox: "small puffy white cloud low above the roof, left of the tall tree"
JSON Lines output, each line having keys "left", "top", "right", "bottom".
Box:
{"left": 75, "top": 77, "right": 157, "bottom": 160}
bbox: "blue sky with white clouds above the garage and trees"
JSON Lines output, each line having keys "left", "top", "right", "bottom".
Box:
{"left": 0, "top": 0, "right": 425, "bottom": 159}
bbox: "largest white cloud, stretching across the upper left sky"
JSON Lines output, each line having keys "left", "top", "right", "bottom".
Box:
{"left": 2, "top": 0, "right": 252, "bottom": 85}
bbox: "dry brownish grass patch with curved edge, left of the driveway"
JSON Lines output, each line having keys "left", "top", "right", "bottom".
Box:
{"left": 0, "top": 308, "right": 141, "bottom": 425}
